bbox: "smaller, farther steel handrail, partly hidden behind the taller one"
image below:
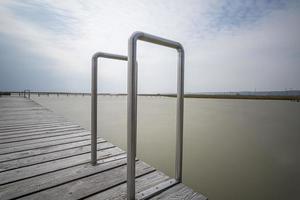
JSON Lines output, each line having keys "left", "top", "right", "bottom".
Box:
{"left": 91, "top": 52, "right": 127, "bottom": 165}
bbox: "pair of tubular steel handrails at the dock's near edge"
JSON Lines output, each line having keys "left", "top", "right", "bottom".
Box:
{"left": 91, "top": 32, "right": 184, "bottom": 200}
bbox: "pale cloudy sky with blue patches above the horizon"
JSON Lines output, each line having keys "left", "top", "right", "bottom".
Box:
{"left": 0, "top": 0, "right": 300, "bottom": 93}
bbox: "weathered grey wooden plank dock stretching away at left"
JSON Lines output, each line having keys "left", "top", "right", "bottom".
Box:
{"left": 0, "top": 96, "right": 206, "bottom": 200}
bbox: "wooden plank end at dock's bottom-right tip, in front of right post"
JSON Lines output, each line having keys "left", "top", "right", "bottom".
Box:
{"left": 150, "top": 183, "right": 207, "bottom": 200}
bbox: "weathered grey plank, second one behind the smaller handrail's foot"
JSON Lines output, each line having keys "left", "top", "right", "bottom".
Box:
{"left": 0, "top": 142, "right": 115, "bottom": 172}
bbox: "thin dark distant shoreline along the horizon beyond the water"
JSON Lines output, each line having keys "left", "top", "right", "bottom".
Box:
{"left": 0, "top": 91, "right": 300, "bottom": 102}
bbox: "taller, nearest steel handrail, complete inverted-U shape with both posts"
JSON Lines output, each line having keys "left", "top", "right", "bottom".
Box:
{"left": 127, "top": 32, "right": 184, "bottom": 200}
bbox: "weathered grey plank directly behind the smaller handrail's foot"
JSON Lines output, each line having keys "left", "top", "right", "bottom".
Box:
{"left": 0, "top": 147, "right": 124, "bottom": 185}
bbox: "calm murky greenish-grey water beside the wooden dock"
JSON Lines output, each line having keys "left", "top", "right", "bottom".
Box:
{"left": 33, "top": 96, "right": 300, "bottom": 200}
